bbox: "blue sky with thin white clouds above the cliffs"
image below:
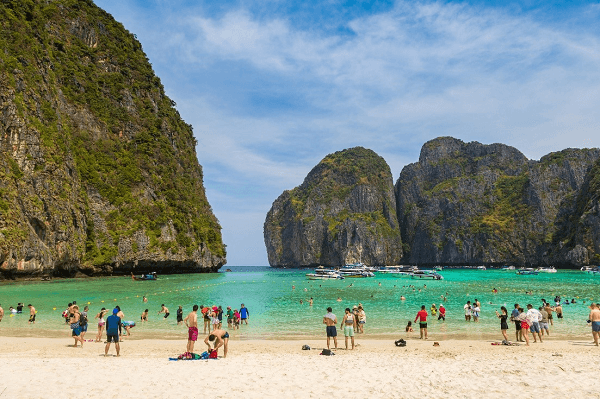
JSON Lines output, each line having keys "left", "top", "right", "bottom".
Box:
{"left": 94, "top": 0, "right": 600, "bottom": 266}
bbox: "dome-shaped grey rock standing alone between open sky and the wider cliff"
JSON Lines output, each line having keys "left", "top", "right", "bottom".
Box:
{"left": 264, "top": 147, "right": 402, "bottom": 267}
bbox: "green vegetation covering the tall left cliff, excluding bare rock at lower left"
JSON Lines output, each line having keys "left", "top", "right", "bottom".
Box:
{"left": 0, "top": 0, "right": 225, "bottom": 276}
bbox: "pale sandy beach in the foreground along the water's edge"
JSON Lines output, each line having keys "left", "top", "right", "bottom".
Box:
{"left": 0, "top": 337, "right": 600, "bottom": 398}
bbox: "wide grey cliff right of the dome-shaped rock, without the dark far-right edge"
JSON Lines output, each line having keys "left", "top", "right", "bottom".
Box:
{"left": 396, "top": 137, "right": 600, "bottom": 265}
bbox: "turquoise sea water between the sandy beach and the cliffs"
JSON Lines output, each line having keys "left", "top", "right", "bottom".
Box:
{"left": 0, "top": 267, "right": 600, "bottom": 339}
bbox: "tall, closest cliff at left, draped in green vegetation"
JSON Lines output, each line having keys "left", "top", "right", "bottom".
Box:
{"left": 0, "top": 0, "right": 226, "bottom": 277}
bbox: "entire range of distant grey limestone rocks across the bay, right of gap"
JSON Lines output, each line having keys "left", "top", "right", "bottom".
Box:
{"left": 264, "top": 137, "right": 600, "bottom": 267}
